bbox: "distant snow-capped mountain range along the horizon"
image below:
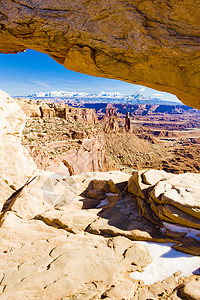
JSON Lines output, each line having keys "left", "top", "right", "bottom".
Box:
{"left": 28, "top": 91, "right": 181, "bottom": 105}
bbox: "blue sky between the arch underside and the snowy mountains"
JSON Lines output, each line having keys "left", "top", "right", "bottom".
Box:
{"left": 0, "top": 50, "right": 177, "bottom": 101}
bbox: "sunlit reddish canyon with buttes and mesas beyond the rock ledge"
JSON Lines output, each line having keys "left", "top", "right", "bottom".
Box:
{"left": 17, "top": 99, "right": 200, "bottom": 175}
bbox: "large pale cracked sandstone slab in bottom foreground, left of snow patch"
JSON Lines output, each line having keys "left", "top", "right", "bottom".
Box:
{"left": 0, "top": 212, "right": 151, "bottom": 299}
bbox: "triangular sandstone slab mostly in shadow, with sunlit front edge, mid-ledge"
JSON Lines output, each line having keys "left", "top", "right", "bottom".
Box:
{"left": 87, "top": 194, "right": 170, "bottom": 242}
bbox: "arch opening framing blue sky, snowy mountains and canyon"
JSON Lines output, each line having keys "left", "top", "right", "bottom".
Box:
{"left": 0, "top": 51, "right": 200, "bottom": 173}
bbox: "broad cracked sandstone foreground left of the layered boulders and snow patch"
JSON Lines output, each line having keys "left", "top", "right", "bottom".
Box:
{"left": 0, "top": 171, "right": 198, "bottom": 300}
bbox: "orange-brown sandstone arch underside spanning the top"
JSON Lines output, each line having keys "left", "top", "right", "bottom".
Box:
{"left": 0, "top": 0, "right": 200, "bottom": 108}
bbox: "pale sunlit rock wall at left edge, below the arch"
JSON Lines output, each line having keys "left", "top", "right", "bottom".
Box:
{"left": 0, "top": 91, "right": 36, "bottom": 204}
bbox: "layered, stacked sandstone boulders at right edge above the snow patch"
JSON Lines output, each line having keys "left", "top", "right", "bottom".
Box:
{"left": 127, "top": 170, "right": 200, "bottom": 255}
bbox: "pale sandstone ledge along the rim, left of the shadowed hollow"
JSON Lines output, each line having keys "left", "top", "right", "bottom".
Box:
{"left": 2, "top": 171, "right": 130, "bottom": 219}
